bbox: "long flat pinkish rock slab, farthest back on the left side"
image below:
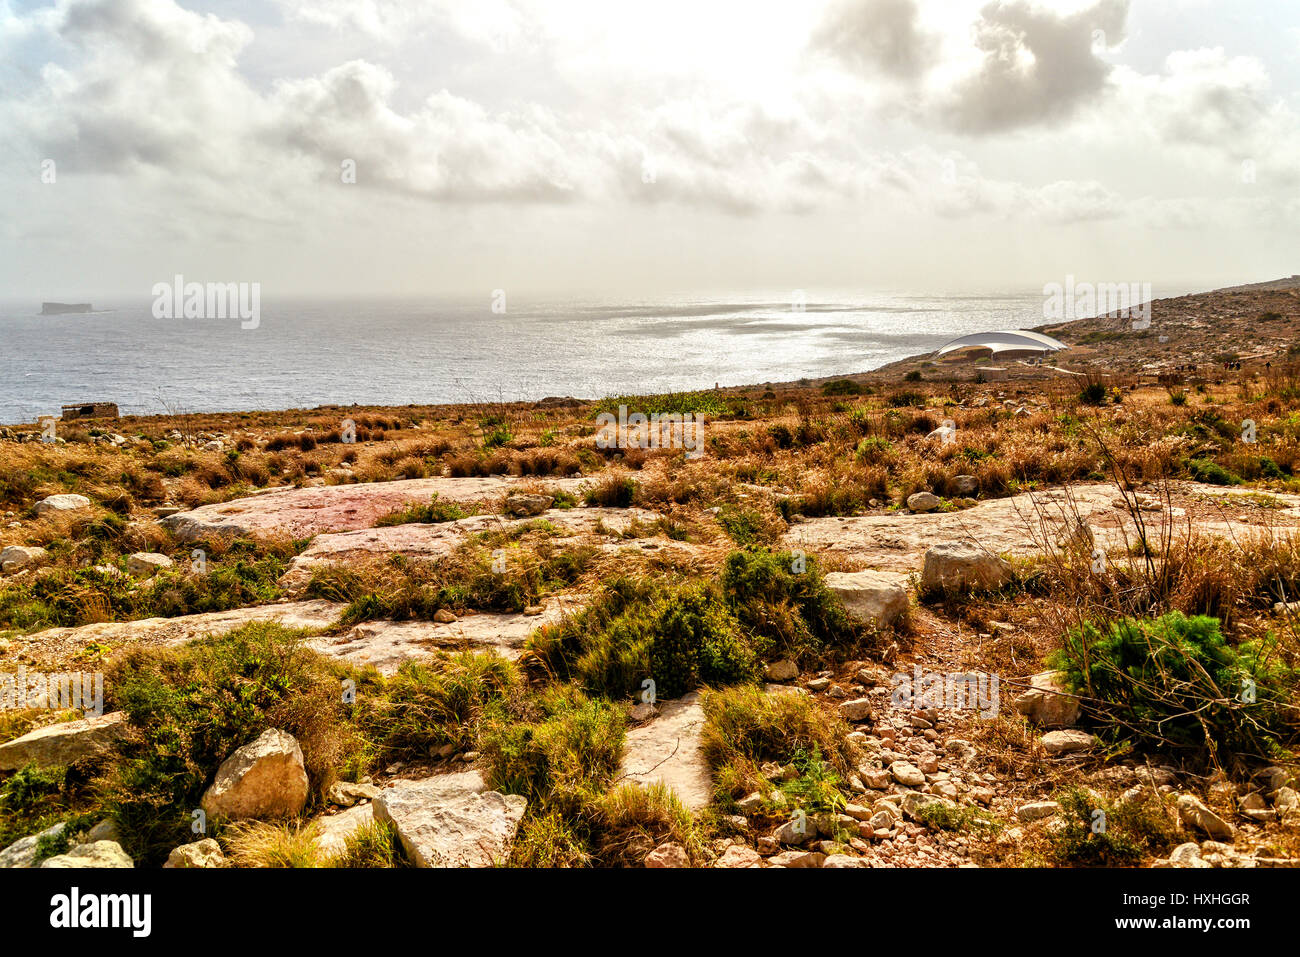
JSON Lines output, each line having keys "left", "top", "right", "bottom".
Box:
{"left": 161, "top": 476, "right": 586, "bottom": 541}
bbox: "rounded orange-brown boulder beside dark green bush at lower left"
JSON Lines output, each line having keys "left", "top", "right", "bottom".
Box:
{"left": 202, "top": 728, "right": 307, "bottom": 820}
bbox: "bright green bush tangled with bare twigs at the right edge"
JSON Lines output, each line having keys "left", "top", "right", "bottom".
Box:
{"left": 1049, "top": 611, "right": 1296, "bottom": 762}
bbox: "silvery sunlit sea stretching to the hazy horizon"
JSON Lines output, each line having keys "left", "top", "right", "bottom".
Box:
{"left": 0, "top": 294, "right": 1043, "bottom": 423}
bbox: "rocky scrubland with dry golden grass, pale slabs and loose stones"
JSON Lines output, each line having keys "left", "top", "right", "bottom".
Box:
{"left": 0, "top": 283, "right": 1300, "bottom": 867}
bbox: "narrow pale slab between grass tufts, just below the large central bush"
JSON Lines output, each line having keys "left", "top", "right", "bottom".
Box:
{"left": 618, "top": 692, "right": 714, "bottom": 810}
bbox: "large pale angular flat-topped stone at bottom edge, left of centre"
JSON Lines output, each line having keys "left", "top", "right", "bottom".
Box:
{"left": 373, "top": 771, "right": 528, "bottom": 867}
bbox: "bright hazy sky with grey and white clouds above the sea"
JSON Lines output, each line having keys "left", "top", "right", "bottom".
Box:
{"left": 0, "top": 0, "right": 1300, "bottom": 300}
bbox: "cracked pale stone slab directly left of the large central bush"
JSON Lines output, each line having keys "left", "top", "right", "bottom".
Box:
{"left": 307, "top": 597, "right": 581, "bottom": 675}
